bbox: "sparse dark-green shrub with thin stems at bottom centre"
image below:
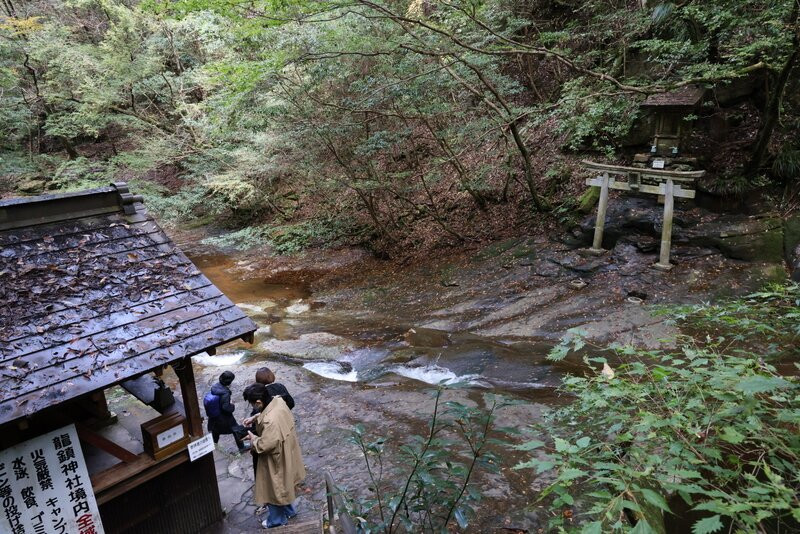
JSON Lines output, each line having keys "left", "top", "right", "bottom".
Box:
{"left": 347, "top": 386, "right": 505, "bottom": 534}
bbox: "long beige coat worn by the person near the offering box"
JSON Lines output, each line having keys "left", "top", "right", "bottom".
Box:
{"left": 252, "top": 397, "right": 306, "bottom": 505}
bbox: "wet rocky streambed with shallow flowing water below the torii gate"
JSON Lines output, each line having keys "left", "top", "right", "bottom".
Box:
{"left": 182, "top": 199, "right": 788, "bottom": 532}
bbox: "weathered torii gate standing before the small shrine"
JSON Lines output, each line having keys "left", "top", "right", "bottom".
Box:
{"left": 582, "top": 160, "right": 706, "bottom": 271}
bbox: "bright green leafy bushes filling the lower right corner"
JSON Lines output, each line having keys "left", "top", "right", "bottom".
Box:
{"left": 518, "top": 284, "right": 800, "bottom": 533}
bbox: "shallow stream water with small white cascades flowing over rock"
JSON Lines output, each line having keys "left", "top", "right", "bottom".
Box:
{"left": 193, "top": 254, "right": 561, "bottom": 397}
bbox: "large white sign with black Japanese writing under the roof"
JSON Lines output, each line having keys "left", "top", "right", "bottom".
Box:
{"left": 0, "top": 425, "right": 104, "bottom": 534}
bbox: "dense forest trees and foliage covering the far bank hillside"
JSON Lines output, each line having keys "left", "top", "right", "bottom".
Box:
{"left": 0, "top": 0, "right": 797, "bottom": 251}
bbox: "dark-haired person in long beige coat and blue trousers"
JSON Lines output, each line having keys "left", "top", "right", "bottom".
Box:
{"left": 247, "top": 384, "right": 306, "bottom": 528}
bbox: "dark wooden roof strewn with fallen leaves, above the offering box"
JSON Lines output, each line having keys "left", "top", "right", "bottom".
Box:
{"left": 0, "top": 184, "right": 256, "bottom": 424}
